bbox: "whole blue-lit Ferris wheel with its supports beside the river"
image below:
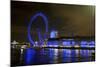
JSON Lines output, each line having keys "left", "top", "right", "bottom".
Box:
{"left": 28, "top": 12, "right": 48, "bottom": 46}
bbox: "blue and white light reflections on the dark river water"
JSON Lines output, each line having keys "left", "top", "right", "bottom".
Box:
{"left": 23, "top": 48, "right": 94, "bottom": 65}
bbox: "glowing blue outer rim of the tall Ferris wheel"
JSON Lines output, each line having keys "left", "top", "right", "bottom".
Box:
{"left": 28, "top": 12, "right": 48, "bottom": 46}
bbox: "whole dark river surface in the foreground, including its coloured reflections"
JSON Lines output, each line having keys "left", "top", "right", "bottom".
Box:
{"left": 11, "top": 48, "right": 95, "bottom": 66}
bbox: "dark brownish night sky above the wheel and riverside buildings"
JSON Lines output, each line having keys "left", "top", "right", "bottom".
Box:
{"left": 11, "top": 1, "right": 95, "bottom": 42}
